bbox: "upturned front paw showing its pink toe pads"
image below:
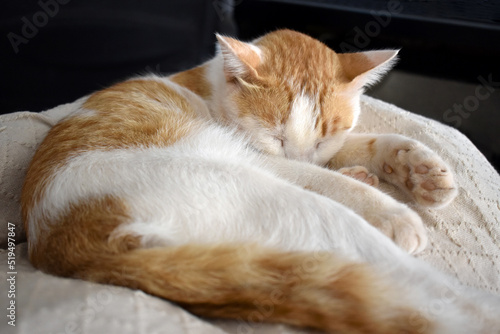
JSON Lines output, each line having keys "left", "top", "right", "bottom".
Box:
{"left": 380, "top": 141, "right": 457, "bottom": 207}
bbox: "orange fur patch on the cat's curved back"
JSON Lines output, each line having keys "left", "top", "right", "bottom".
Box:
{"left": 51, "top": 76, "right": 212, "bottom": 154}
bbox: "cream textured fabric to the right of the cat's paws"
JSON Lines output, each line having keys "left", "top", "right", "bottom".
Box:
{"left": 356, "top": 97, "right": 500, "bottom": 295}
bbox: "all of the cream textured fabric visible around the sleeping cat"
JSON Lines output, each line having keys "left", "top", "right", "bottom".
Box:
{"left": 0, "top": 97, "right": 500, "bottom": 334}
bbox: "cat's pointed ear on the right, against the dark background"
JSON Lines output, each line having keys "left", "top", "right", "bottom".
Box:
{"left": 338, "top": 50, "right": 399, "bottom": 89}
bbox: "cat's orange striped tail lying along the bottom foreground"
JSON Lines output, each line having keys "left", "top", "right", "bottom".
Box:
{"left": 80, "top": 245, "right": 431, "bottom": 334}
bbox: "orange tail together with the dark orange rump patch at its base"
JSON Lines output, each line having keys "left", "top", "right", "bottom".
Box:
{"left": 25, "top": 198, "right": 428, "bottom": 334}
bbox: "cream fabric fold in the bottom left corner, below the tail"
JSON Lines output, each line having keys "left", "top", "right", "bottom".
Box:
{"left": 0, "top": 243, "right": 229, "bottom": 334}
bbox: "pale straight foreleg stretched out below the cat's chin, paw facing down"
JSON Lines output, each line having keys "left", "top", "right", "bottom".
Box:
{"left": 263, "top": 156, "right": 427, "bottom": 253}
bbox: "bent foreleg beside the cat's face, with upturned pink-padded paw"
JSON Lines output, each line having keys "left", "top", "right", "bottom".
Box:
{"left": 328, "top": 134, "right": 457, "bottom": 207}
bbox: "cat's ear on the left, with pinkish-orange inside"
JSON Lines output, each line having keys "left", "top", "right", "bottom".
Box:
{"left": 216, "top": 34, "right": 261, "bottom": 81}
